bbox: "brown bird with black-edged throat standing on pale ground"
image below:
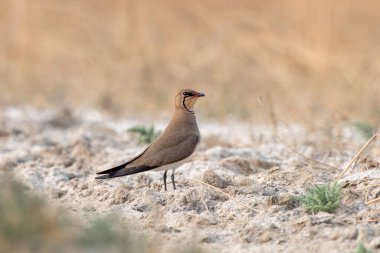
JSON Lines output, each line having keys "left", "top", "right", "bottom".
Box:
{"left": 96, "top": 89, "right": 205, "bottom": 191}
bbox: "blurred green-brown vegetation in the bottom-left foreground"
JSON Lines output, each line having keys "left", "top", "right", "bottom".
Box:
{"left": 0, "top": 179, "right": 204, "bottom": 253}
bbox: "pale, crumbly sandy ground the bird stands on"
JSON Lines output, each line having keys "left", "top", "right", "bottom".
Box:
{"left": 0, "top": 108, "right": 380, "bottom": 252}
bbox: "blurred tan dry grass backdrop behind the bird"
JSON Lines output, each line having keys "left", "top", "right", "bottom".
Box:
{"left": 0, "top": 0, "right": 380, "bottom": 119}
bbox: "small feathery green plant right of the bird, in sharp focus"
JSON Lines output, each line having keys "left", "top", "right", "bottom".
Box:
{"left": 294, "top": 183, "right": 342, "bottom": 213}
